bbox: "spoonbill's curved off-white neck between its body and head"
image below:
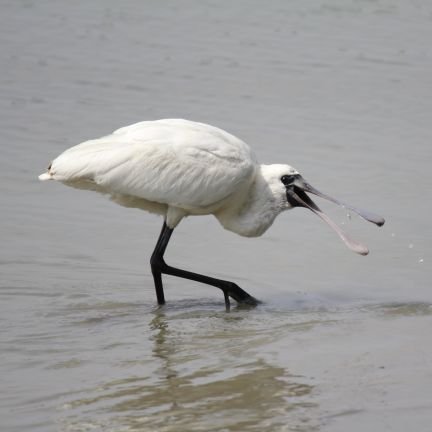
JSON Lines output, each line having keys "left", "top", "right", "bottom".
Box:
{"left": 215, "top": 165, "right": 284, "bottom": 237}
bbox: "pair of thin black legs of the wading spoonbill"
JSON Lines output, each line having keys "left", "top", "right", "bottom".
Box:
{"left": 150, "top": 222, "right": 259, "bottom": 309}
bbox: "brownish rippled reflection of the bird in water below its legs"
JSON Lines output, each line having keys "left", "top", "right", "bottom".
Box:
{"left": 107, "top": 310, "right": 313, "bottom": 431}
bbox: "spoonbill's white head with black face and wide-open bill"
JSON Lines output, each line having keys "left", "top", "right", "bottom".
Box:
{"left": 265, "top": 165, "right": 385, "bottom": 255}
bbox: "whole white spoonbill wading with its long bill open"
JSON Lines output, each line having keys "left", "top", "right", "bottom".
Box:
{"left": 39, "top": 119, "right": 384, "bottom": 308}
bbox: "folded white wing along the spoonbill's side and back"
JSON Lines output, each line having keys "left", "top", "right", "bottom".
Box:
{"left": 50, "top": 120, "right": 256, "bottom": 209}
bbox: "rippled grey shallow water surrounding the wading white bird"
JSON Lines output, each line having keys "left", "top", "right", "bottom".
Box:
{"left": 0, "top": 0, "right": 432, "bottom": 432}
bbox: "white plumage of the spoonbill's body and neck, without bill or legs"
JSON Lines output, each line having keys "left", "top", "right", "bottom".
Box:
{"left": 39, "top": 119, "right": 297, "bottom": 236}
